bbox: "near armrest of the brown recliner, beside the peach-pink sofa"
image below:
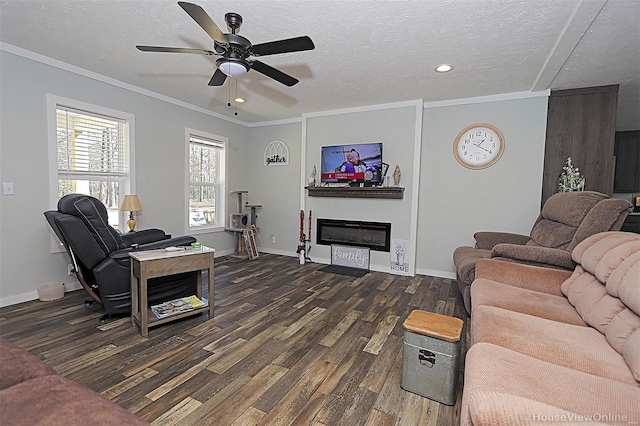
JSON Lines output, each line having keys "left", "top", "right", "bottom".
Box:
{"left": 491, "top": 244, "right": 576, "bottom": 269}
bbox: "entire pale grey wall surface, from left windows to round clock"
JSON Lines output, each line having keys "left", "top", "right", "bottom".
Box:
{"left": 0, "top": 46, "right": 547, "bottom": 305}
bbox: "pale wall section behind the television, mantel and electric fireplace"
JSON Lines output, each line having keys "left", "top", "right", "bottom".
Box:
{"left": 301, "top": 103, "right": 421, "bottom": 271}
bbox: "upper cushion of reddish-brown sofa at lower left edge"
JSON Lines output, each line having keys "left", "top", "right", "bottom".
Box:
{"left": 0, "top": 337, "right": 57, "bottom": 389}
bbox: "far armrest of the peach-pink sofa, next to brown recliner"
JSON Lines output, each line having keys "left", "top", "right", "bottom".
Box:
{"left": 476, "top": 259, "right": 572, "bottom": 296}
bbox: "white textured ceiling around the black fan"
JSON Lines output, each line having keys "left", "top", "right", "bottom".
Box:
{"left": 0, "top": 0, "right": 640, "bottom": 130}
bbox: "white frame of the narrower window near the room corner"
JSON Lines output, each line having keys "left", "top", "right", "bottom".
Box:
{"left": 184, "top": 127, "right": 229, "bottom": 235}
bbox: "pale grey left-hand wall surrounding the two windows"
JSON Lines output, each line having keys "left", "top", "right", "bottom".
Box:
{"left": 0, "top": 51, "right": 249, "bottom": 305}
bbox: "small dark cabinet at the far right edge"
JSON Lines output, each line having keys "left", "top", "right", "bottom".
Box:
{"left": 613, "top": 130, "right": 640, "bottom": 192}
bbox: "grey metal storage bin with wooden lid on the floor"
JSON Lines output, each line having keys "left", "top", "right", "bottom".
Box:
{"left": 400, "top": 311, "right": 463, "bottom": 405}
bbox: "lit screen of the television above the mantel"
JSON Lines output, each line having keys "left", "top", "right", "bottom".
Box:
{"left": 320, "top": 142, "right": 382, "bottom": 184}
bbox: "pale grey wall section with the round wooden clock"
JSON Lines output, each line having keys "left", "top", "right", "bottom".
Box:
{"left": 417, "top": 94, "right": 548, "bottom": 277}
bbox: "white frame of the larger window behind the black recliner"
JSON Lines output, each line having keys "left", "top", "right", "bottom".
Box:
{"left": 47, "top": 93, "right": 136, "bottom": 253}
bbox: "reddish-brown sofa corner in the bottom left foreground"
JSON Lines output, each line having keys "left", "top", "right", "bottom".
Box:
{"left": 0, "top": 337, "right": 148, "bottom": 426}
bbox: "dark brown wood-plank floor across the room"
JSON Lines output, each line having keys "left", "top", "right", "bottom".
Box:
{"left": 0, "top": 254, "right": 468, "bottom": 426}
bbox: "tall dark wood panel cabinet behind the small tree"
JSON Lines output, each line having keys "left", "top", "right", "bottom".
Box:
{"left": 542, "top": 85, "right": 618, "bottom": 205}
